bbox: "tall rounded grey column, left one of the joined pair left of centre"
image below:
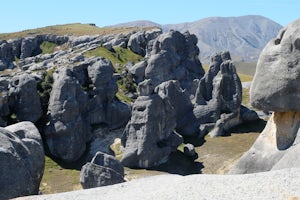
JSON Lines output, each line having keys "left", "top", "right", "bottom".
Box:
{"left": 45, "top": 68, "right": 91, "bottom": 162}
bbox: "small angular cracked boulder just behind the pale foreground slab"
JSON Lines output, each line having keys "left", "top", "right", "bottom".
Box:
{"left": 80, "top": 152, "right": 125, "bottom": 189}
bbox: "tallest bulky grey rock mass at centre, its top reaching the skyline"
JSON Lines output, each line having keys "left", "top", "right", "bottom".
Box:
{"left": 145, "top": 31, "right": 204, "bottom": 94}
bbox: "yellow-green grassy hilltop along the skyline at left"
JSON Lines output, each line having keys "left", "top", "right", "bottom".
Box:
{"left": 0, "top": 23, "right": 153, "bottom": 40}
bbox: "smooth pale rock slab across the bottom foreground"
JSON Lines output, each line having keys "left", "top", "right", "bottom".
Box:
{"left": 15, "top": 168, "right": 300, "bottom": 200}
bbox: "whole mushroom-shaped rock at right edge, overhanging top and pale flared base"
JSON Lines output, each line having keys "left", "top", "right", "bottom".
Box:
{"left": 230, "top": 20, "right": 300, "bottom": 174}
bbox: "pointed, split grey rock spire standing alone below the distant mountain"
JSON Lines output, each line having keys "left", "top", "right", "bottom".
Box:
{"left": 191, "top": 52, "right": 242, "bottom": 137}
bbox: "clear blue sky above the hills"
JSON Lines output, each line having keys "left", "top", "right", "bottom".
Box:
{"left": 0, "top": 0, "right": 300, "bottom": 33}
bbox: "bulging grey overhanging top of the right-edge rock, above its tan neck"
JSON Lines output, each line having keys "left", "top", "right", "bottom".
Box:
{"left": 250, "top": 20, "right": 300, "bottom": 112}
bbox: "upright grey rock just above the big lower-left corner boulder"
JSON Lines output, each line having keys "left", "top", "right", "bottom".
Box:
{"left": 9, "top": 73, "right": 42, "bottom": 122}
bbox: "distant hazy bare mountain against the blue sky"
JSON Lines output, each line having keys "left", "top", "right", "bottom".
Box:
{"left": 111, "top": 15, "right": 282, "bottom": 63}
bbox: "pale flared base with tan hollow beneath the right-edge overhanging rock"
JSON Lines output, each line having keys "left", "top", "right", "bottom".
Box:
{"left": 229, "top": 112, "right": 300, "bottom": 174}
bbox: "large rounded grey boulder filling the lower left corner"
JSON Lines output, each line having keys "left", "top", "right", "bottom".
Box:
{"left": 0, "top": 122, "right": 45, "bottom": 199}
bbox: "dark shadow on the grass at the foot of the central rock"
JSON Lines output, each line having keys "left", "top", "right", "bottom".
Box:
{"left": 151, "top": 151, "right": 204, "bottom": 175}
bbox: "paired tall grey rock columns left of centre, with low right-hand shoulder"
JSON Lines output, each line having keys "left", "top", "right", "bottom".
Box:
{"left": 45, "top": 58, "right": 131, "bottom": 162}
